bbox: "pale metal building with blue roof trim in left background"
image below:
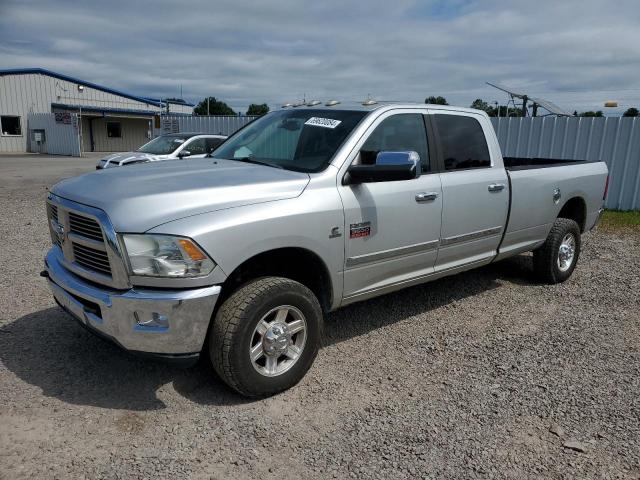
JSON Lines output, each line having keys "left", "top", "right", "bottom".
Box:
{"left": 0, "top": 68, "right": 194, "bottom": 152}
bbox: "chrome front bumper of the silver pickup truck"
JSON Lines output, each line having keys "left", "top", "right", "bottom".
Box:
{"left": 43, "top": 248, "right": 220, "bottom": 364}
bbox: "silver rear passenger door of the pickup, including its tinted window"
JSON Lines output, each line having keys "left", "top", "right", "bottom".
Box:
{"left": 429, "top": 110, "right": 509, "bottom": 271}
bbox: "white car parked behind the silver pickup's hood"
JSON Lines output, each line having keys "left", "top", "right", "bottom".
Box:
{"left": 96, "top": 133, "right": 227, "bottom": 170}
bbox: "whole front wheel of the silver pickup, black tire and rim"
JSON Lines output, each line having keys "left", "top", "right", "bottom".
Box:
{"left": 209, "top": 277, "right": 323, "bottom": 397}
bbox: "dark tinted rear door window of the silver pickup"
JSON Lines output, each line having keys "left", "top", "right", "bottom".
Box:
{"left": 432, "top": 114, "right": 491, "bottom": 170}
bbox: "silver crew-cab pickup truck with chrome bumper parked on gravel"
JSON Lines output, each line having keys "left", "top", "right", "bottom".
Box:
{"left": 42, "top": 102, "right": 608, "bottom": 396}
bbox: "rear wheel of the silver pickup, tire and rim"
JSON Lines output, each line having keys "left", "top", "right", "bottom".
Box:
{"left": 533, "top": 218, "right": 581, "bottom": 284}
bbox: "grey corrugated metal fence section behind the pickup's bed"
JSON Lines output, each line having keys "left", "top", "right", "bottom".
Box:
{"left": 491, "top": 117, "right": 640, "bottom": 210}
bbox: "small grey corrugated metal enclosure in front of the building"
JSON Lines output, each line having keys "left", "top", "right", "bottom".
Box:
{"left": 27, "top": 113, "right": 80, "bottom": 157}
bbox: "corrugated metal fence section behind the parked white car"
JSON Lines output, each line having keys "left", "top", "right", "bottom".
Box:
{"left": 153, "top": 115, "right": 257, "bottom": 136}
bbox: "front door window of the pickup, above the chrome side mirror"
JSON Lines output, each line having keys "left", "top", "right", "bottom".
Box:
{"left": 360, "top": 113, "right": 431, "bottom": 172}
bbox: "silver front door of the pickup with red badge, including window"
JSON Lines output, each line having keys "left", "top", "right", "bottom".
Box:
{"left": 338, "top": 109, "right": 442, "bottom": 300}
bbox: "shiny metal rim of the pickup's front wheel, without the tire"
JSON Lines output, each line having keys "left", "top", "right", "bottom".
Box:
{"left": 249, "top": 305, "right": 307, "bottom": 377}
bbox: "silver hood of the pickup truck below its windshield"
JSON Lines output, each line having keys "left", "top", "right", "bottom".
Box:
{"left": 51, "top": 158, "right": 309, "bottom": 232}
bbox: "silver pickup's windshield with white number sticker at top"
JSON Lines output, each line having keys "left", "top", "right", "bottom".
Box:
{"left": 213, "top": 109, "right": 368, "bottom": 172}
